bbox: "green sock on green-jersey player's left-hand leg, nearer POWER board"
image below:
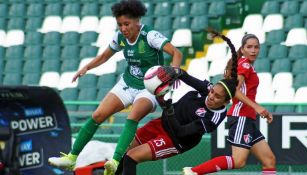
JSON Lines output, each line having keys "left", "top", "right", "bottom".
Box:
{"left": 70, "top": 117, "right": 99, "bottom": 155}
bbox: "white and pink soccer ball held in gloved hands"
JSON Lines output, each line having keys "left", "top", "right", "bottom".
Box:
{"left": 144, "top": 66, "right": 171, "bottom": 96}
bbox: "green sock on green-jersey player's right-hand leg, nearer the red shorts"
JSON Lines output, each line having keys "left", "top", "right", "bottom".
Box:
{"left": 113, "top": 119, "right": 138, "bottom": 161}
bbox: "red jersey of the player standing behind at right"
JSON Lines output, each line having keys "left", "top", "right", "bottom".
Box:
{"left": 227, "top": 58, "right": 259, "bottom": 120}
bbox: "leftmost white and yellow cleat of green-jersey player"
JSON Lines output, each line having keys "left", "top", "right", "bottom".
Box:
{"left": 48, "top": 152, "right": 77, "bottom": 171}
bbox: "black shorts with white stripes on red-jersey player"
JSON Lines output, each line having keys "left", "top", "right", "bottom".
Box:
{"left": 227, "top": 116, "right": 265, "bottom": 149}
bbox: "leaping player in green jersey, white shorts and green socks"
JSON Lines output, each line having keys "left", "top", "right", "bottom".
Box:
{"left": 49, "top": 0, "right": 182, "bottom": 174}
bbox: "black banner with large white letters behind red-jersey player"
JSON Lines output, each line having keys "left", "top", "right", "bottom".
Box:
{"left": 211, "top": 114, "right": 307, "bottom": 165}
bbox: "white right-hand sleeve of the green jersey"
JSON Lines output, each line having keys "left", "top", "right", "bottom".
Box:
{"left": 147, "top": 30, "right": 169, "bottom": 50}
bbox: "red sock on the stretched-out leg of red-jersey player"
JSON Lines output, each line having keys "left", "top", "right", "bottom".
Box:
{"left": 192, "top": 156, "right": 234, "bottom": 174}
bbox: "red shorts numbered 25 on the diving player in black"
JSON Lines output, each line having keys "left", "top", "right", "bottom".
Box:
{"left": 135, "top": 118, "right": 179, "bottom": 160}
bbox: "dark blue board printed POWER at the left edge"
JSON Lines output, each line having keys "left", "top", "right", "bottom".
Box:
{"left": 0, "top": 86, "right": 71, "bottom": 175}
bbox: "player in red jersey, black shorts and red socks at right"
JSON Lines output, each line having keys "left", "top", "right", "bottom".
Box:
{"left": 183, "top": 34, "right": 276, "bottom": 175}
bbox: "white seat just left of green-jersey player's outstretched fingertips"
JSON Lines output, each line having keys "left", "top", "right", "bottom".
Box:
{"left": 57, "top": 71, "right": 79, "bottom": 90}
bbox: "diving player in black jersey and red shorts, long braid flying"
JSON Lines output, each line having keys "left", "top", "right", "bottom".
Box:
{"left": 116, "top": 31, "right": 268, "bottom": 175}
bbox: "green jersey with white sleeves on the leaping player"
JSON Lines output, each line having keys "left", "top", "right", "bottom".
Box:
{"left": 110, "top": 25, "right": 169, "bottom": 89}
